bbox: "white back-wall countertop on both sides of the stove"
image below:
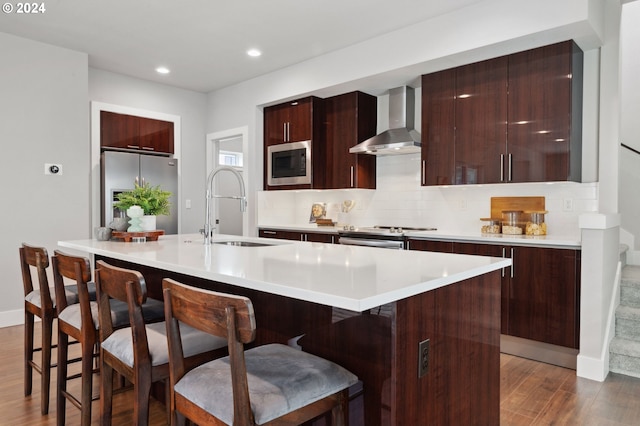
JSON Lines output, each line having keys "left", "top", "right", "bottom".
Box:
{"left": 258, "top": 224, "right": 582, "bottom": 250}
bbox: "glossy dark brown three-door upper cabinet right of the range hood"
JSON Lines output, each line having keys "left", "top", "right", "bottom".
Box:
{"left": 422, "top": 41, "right": 583, "bottom": 185}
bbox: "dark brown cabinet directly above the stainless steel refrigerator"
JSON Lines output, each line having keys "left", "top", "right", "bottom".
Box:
{"left": 100, "top": 111, "right": 174, "bottom": 154}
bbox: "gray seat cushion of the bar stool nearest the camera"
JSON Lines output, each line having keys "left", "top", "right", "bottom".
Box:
{"left": 175, "top": 344, "right": 358, "bottom": 425}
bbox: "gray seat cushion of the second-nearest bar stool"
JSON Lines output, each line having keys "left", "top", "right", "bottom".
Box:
{"left": 102, "top": 321, "right": 227, "bottom": 367}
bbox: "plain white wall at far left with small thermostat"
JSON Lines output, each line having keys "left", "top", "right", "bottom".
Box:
{"left": 0, "top": 33, "right": 91, "bottom": 326}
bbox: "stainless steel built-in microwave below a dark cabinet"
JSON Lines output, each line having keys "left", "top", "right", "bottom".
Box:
{"left": 267, "top": 141, "right": 311, "bottom": 186}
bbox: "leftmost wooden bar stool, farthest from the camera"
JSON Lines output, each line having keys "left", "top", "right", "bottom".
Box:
{"left": 19, "top": 243, "right": 85, "bottom": 415}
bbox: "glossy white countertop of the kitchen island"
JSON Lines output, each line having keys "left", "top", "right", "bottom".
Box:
{"left": 58, "top": 234, "right": 511, "bottom": 312}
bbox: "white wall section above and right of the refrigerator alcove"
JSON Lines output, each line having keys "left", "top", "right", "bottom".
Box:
{"left": 89, "top": 68, "right": 207, "bottom": 233}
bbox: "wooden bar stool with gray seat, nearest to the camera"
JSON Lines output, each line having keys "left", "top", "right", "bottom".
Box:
{"left": 163, "top": 279, "right": 358, "bottom": 426}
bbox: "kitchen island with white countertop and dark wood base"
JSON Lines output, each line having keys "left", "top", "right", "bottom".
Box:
{"left": 59, "top": 235, "right": 511, "bottom": 426}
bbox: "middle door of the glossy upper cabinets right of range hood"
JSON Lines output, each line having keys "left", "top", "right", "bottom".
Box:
{"left": 455, "top": 57, "right": 508, "bottom": 184}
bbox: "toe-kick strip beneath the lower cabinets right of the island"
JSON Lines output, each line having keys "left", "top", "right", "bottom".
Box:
{"left": 500, "top": 334, "right": 578, "bottom": 370}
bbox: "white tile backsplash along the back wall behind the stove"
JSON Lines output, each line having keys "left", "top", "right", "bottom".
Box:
{"left": 257, "top": 154, "right": 598, "bottom": 237}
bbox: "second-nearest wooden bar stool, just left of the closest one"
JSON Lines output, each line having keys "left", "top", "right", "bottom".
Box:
{"left": 95, "top": 261, "right": 227, "bottom": 426}
